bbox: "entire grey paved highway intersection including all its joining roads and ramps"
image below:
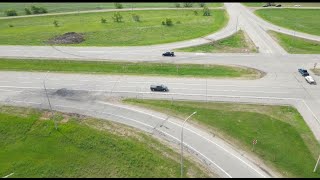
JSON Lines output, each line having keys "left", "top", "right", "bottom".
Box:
{"left": 0, "top": 3, "right": 320, "bottom": 177}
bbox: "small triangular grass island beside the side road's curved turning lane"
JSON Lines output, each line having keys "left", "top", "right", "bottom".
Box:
{"left": 177, "top": 30, "right": 258, "bottom": 53}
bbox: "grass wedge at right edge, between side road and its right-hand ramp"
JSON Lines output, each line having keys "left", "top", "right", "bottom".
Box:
{"left": 268, "top": 31, "right": 320, "bottom": 54}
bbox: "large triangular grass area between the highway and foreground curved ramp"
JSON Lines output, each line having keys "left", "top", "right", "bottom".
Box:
{"left": 124, "top": 99, "right": 320, "bottom": 178}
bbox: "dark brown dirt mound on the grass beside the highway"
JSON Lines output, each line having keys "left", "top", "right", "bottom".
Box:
{"left": 48, "top": 32, "right": 85, "bottom": 44}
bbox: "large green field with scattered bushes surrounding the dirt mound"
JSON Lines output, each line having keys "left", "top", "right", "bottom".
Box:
{"left": 0, "top": 9, "right": 228, "bottom": 46}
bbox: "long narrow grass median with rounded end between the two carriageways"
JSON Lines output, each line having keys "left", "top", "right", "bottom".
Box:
{"left": 0, "top": 59, "right": 264, "bottom": 79}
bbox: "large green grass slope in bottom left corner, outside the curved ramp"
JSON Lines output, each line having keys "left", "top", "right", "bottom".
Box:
{"left": 0, "top": 106, "right": 209, "bottom": 178}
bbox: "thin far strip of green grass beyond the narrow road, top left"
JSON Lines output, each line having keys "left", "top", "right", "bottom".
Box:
{"left": 0, "top": 3, "right": 223, "bottom": 17}
